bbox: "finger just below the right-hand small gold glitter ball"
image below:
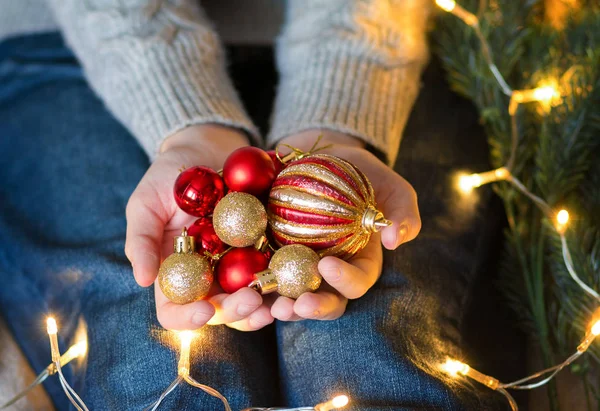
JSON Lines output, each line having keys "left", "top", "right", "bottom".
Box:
{"left": 294, "top": 291, "right": 348, "bottom": 320}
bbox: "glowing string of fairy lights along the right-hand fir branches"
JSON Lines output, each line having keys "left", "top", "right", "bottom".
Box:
{"left": 436, "top": 0, "right": 600, "bottom": 411}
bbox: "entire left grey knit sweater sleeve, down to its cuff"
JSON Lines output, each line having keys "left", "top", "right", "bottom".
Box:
{"left": 50, "top": 0, "right": 258, "bottom": 159}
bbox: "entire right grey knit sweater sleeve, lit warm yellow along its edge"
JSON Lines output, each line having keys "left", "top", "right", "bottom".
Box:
{"left": 268, "top": 0, "right": 430, "bottom": 163}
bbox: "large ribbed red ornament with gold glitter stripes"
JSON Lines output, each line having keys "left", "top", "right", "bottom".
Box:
{"left": 268, "top": 154, "right": 391, "bottom": 259}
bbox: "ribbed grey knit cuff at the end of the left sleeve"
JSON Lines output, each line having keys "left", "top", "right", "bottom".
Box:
{"left": 98, "top": 32, "right": 259, "bottom": 160}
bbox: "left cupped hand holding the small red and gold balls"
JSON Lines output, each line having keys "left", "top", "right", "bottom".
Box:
{"left": 125, "top": 125, "right": 273, "bottom": 330}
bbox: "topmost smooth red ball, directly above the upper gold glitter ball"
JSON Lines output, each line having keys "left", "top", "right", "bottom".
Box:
{"left": 223, "top": 147, "right": 277, "bottom": 196}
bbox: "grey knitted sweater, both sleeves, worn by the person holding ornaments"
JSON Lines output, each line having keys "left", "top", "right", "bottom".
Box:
{"left": 0, "top": 0, "right": 430, "bottom": 162}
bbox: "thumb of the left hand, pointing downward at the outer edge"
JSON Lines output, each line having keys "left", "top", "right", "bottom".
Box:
{"left": 125, "top": 187, "right": 169, "bottom": 287}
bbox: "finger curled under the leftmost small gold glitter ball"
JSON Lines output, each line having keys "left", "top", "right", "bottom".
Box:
{"left": 154, "top": 284, "right": 215, "bottom": 330}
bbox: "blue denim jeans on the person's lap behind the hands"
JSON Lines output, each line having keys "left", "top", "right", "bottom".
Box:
{"left": 0, "top": 34, "right": 496, "bottom": 410}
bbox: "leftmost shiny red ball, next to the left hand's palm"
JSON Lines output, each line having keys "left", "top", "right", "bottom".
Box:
{"left": 173, "top": 166, "right": 225, "bottom": 217}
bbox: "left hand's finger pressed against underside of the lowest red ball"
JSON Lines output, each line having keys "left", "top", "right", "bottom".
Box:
{"left": 208, "top": 287, "right": 263, "bottom": 325}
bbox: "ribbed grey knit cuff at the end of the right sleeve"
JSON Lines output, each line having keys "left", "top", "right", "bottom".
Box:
{"left": 268, "top": 49, "right": 423, "bottom": 163}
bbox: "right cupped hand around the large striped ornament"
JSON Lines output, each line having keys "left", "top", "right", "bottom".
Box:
{"left": 271, "top": 130, "right": 421, "bottom": 321}
